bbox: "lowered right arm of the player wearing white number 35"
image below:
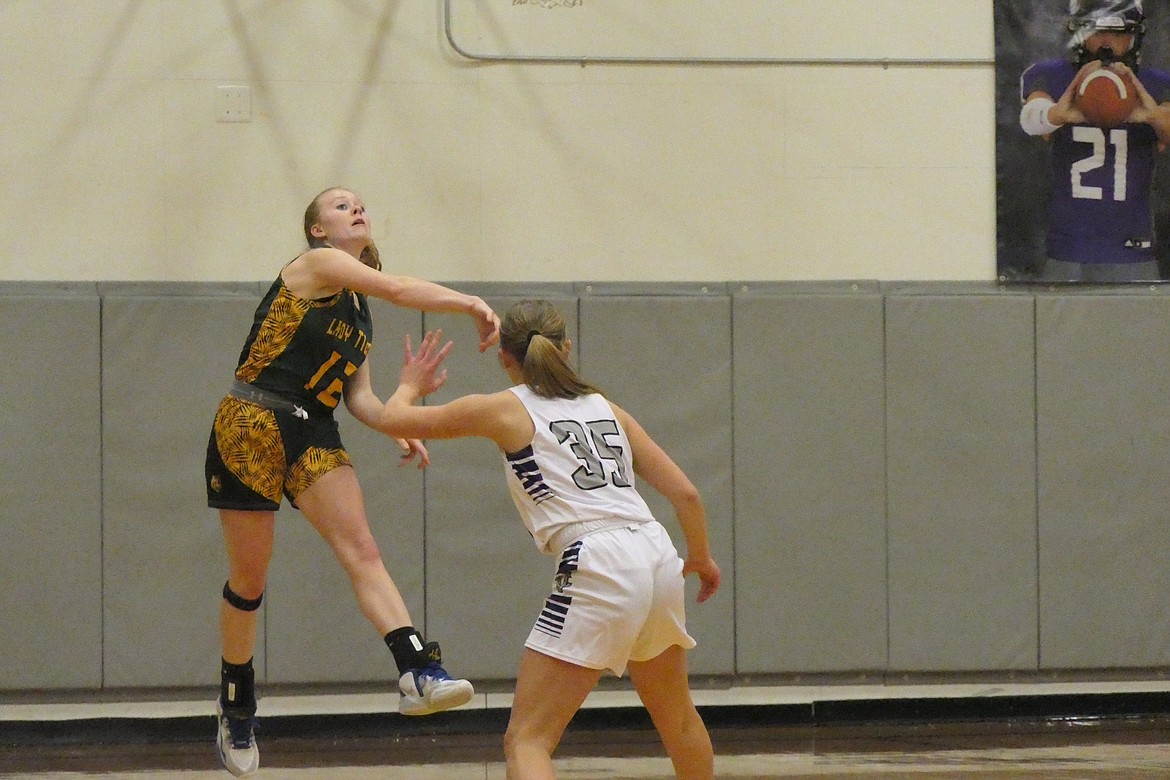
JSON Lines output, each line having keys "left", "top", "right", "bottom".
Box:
{"left": 610, "top": 401, "right": 722, "bottom": 603}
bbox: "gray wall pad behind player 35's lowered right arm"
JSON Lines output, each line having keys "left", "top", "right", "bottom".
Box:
{"left": 577, "top": 287, "right": 736, "bottom": 674}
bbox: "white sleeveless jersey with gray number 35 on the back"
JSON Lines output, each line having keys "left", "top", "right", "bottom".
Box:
{"left": 504, "top": 385, "right": 654, "bottom": 554}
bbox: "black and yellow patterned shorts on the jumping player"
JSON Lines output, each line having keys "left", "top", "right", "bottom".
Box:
{"left": 204, "top": 395, "right": 350, "bottom": 511}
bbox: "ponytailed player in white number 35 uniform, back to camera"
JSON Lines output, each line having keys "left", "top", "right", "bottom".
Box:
{"left": 379, "top": 295, "right": 720, "bottom": 780}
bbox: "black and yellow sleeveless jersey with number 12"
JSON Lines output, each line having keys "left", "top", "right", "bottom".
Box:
{"left": 235, "top": 276, "right": 373, "bottom": 416}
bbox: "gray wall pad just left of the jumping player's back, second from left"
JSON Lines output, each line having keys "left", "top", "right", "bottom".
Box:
{"left": 102, "top": 294, "right": 264, "bottom": 686}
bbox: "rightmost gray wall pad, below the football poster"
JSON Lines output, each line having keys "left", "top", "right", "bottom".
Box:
{"left": 1037, "top": 295, "right": 1170, "bottom": 669}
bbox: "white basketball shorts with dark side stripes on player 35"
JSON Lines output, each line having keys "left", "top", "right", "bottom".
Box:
{"left": 524, "top": 523, "right": 695, "bottom": 677}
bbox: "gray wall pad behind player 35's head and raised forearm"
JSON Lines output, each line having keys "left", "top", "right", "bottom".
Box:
{"left": 425, "top": 285, "right": 577, "bottom": 679}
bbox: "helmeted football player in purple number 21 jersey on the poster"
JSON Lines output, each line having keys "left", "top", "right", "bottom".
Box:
{"left": 1020, "top": 0, "right": 1170, "bottom": 282}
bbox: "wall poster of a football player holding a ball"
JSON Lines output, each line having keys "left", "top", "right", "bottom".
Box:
{"left": 993, "top": 0, "right": 1170, "bottom": 283}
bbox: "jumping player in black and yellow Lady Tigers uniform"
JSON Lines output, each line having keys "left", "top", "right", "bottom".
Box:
{"left": 206, "top": 188, "right": 500, "bottom": 776}
